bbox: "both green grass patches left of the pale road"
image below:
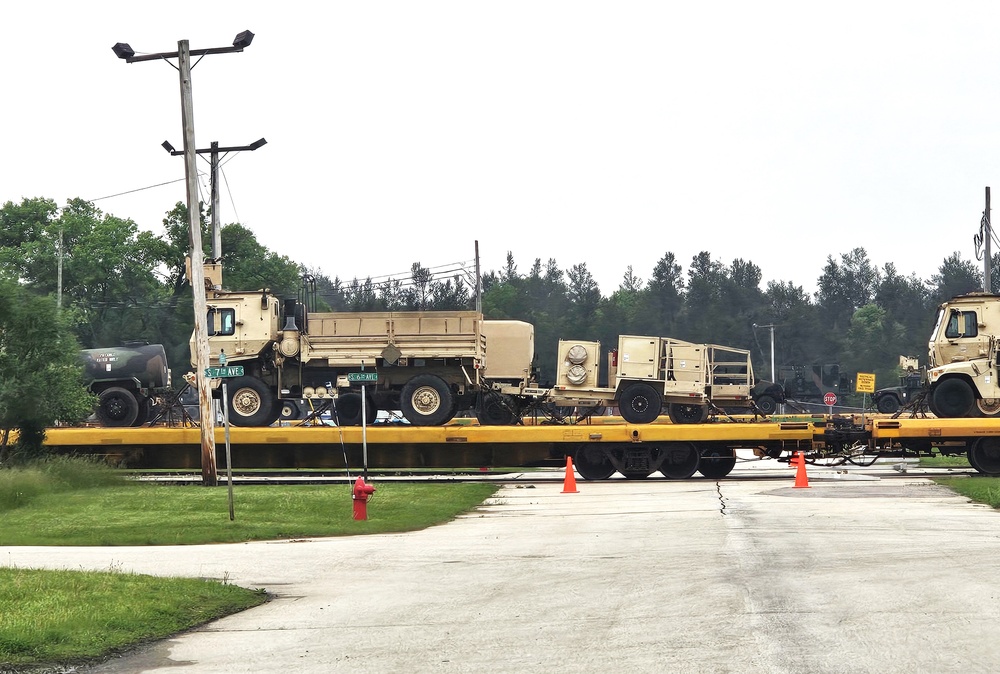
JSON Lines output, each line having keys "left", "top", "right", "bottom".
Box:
{"left": 0, "top": 458, "right": 496, "bottom": 672}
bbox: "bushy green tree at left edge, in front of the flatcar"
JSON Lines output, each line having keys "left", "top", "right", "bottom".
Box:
{"left": 0, "top": 281, "right": 94, "bottom": 463}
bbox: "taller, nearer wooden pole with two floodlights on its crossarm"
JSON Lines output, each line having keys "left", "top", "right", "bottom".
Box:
{"left": 111, "top": 30, "right": 253, "bottom": 487}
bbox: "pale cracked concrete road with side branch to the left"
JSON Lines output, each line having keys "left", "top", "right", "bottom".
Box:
{"left": 0, "top": 463, "right": 1000, "bottom": 674}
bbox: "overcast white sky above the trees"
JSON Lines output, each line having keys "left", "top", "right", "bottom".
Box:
{"left": 0, "top": 0, "right": 1000, "bottom": 295}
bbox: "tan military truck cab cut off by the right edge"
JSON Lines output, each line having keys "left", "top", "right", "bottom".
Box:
{"left": 927, "top": 293, "right": 1000, "bottom": 418}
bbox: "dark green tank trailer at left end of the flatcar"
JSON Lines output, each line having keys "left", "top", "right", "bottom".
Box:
{"left": 80, "top": 342, "right": 171, "bottom": 427}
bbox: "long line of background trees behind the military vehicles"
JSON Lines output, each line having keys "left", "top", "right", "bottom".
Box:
{"left": 0, "top": 192, "right": 1000, "bottom": 440}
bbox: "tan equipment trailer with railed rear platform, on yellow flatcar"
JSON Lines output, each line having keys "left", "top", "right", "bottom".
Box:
{"left": 547, "top": 335, "right": 771, "bottom": 424}
